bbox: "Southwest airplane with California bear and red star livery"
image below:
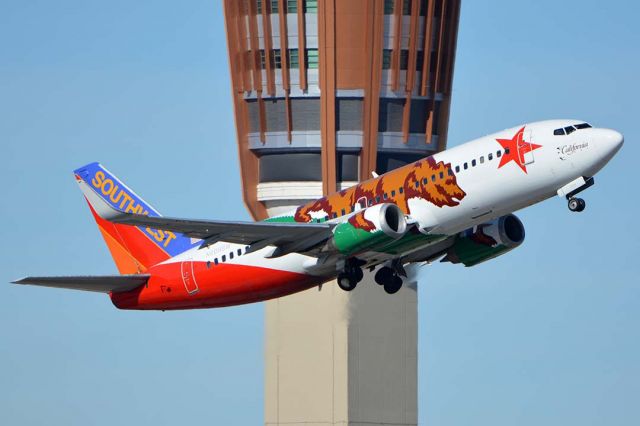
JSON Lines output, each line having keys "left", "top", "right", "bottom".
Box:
{"left": 14, "top": 120, "right": 624, "bottom": 310}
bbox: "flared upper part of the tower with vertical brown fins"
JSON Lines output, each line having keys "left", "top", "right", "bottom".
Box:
{"left": 224, "top": 0, "right": 460, "bottom": 219}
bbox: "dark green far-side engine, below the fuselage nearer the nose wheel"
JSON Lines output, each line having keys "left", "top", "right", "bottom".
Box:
{"left": 442, "top": 214, "right": 524, "bottom": 266}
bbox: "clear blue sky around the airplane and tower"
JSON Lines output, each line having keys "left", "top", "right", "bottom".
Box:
{"left": 0, "top": 0, "right": 640, "bottom": 426}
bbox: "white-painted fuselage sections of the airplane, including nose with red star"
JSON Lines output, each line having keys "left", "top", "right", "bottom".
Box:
{"left": 167, "top": 120, "right": 623, "bottom": 274}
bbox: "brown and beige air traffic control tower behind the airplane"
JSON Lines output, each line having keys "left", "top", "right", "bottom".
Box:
{"left": 224, "top": 0, "right": 460, "bottom": 425}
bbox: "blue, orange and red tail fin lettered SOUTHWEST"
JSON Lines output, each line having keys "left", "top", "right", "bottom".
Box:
{"left": 74, "top": 163, "right": 199, "bottom": 274}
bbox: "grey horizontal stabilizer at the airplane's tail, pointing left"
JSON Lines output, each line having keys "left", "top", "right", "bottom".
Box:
{"left": 13, "top": 274, "right": 150, "bottom": 293}
